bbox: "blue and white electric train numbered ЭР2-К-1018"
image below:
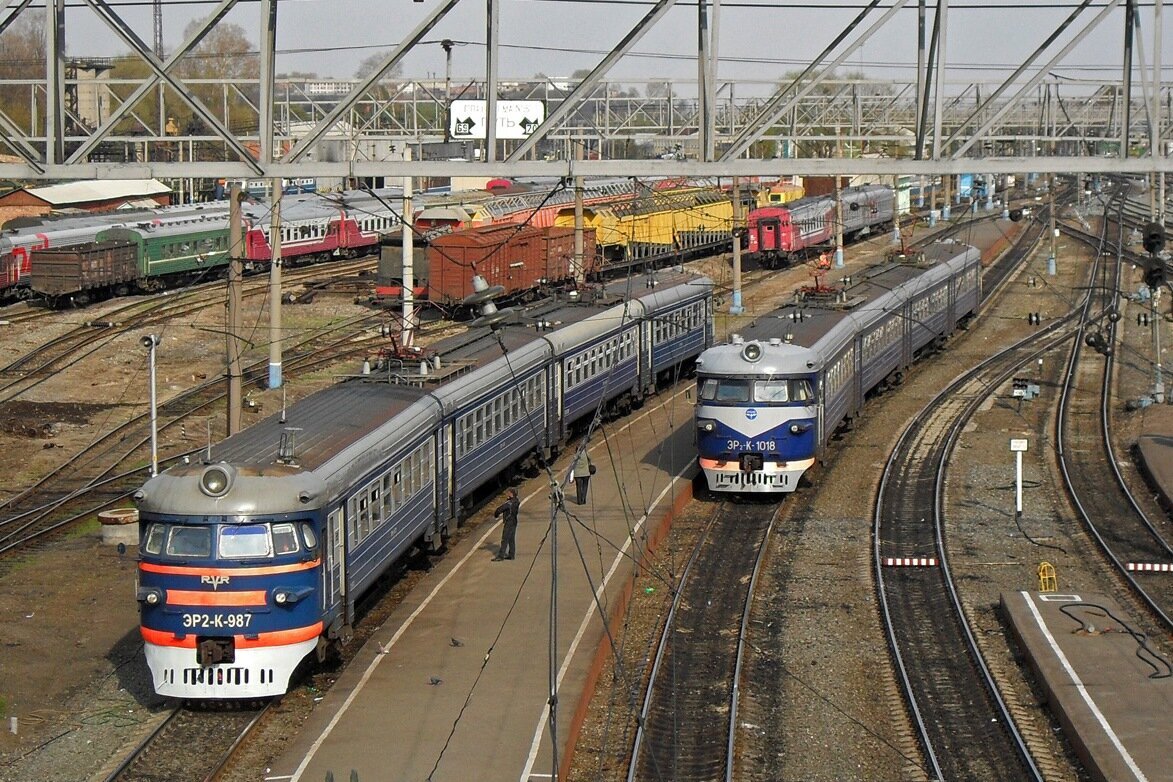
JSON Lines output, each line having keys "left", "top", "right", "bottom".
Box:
{"left": 696, "top": 242, "right": 982, "bottom": 492}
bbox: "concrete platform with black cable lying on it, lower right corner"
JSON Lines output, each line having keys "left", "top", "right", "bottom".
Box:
{"left": 1002, "top": 592, "right": 1173, "bottom": 782}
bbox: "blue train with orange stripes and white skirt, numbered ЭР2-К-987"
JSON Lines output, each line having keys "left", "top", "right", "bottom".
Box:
{"left": 135, "top": 270, "right": 713, "bottom": 699}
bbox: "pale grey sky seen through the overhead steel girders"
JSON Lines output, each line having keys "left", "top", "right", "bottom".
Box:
{"left": 20, "top": 0, "right": 1173, "bottom": 89}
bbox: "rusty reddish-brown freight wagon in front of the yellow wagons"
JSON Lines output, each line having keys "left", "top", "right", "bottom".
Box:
{"left": 427, "top": 225, "right": 595, "bottom": 307}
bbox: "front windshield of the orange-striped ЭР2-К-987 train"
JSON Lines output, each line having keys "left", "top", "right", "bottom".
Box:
{"left": 143, "top": 522, "right": 318, "bottom": 559}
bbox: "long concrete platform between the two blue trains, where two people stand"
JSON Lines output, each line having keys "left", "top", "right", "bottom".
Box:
{"left": 265, "top": 390, "right": 696, "bottom": 782}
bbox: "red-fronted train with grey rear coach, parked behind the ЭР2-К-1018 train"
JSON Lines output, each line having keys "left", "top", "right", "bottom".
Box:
{"left": 744, "top": 184, "right": 896, "bottom": 268}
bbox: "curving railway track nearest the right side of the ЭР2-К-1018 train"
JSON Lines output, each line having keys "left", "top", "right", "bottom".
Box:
{"left": 873, "top": 211, "right": 1090, "bottom": 782}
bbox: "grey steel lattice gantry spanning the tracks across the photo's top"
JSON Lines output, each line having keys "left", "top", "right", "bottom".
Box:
{"left": 0, "top": 0, "right": 1173, "bottom": 179}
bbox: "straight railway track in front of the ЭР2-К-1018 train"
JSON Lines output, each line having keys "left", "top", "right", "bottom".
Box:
{"left": 628, "top": 499, "right": 780, "bottom": 782}
